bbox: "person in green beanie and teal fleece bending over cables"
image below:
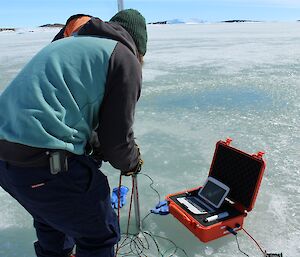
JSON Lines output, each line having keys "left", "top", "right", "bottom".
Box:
{"left": 0, "top": 9, "right": 147, "bottom": 257}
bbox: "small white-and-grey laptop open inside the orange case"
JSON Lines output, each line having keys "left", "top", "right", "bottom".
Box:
{"left": 177, "top": 177, "right": 230, "bottom": 214}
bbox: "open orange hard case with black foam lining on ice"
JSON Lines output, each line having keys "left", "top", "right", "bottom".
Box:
{"left": 166, "top": 139, "right": 266, "bottom": 242}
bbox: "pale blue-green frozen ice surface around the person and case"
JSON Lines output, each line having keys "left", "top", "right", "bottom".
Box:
{"left": 0, "top": 23, "right": 300, "bottom": 257}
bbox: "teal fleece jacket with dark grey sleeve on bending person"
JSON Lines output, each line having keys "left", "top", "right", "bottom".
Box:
{"left": 0, "top": 22, "right": 141, "bottom": 171}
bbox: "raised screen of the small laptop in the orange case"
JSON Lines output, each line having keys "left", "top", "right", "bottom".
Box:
{"left": 198, "top": 177, "right": 229, "bottom": 208}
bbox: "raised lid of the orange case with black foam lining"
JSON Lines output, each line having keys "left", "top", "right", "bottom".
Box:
{"left": 209, "top": 139, "right": 265, "bottom": 211}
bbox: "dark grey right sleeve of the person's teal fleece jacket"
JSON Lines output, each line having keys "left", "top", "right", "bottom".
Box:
{"left": 97, "top": 43, "right": 142, "bottom": 171}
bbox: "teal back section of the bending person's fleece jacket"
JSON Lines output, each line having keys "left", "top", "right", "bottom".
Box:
{"left": 0, "top": 37, "right": 116, "bottom": 154}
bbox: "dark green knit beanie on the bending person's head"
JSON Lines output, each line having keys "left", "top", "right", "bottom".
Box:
{"left": 110, "top": 9, "right": 147, "bottom": 55}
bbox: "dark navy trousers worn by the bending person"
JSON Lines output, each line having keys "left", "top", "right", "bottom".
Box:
{"left": 0, "top": 156, "right": 120, "bottom": 257}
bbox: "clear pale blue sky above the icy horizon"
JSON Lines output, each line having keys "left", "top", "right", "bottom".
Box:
{"left": 0, "top": 0, "right": 300, "bottom": 27}
